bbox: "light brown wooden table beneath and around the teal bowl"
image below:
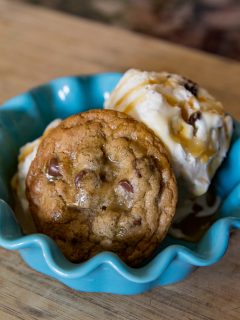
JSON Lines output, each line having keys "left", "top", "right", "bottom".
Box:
{"left": 0, "top": 0, "right": 240, "bottom": 320}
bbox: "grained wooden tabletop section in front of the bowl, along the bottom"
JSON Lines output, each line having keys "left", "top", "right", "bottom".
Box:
{"left": 0, "top": 233, "right": 240, "bottom": 320}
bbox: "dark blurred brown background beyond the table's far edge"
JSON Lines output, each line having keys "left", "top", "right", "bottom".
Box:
{"left": 19, "top": 0, "right": 240, "bottom": 61}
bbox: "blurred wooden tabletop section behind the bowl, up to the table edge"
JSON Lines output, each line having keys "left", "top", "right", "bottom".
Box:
{"left": 0, "top": 0, "right": 240, "bottom": 117}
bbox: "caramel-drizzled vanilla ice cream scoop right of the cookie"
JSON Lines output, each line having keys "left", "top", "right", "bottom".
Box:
{"left": 104, "top": 69, "right": 232, "bottom": 196}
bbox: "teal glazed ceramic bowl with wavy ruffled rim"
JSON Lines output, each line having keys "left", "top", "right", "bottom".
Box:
{"left": 0, "top": 73, "right": 240, "bottom": 294}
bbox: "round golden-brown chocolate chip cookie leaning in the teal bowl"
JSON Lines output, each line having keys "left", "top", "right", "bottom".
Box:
{"left": 26, "top": 110, "right": 177, "bottom": 266}
